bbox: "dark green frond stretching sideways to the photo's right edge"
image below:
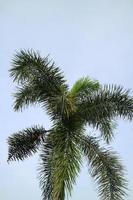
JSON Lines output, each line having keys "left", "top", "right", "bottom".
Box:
{"left": 84, "top": 85, "right": 133, "bottom": 120}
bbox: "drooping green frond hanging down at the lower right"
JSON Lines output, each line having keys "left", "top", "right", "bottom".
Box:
{"left": 80, "top": 136, "right": 127, "bottom": 200}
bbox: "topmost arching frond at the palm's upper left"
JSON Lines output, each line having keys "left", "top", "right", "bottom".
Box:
{"left": 10, "top": 50, "right": 65, "bottom": 87}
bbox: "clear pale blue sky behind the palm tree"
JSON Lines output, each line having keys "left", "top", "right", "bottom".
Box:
{"left": 0, "top": 0, "right": 133, "bottom": 200}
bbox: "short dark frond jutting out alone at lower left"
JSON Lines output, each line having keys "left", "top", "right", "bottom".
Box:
{"left": 8, "top": 126, "right": 46, "bottom": 161}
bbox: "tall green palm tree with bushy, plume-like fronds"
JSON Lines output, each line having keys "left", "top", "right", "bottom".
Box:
{"left": 8, "top": 50, "right": 133, "bottom": 200}
